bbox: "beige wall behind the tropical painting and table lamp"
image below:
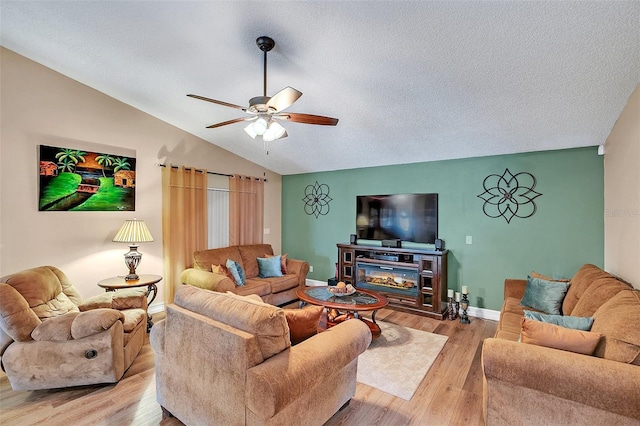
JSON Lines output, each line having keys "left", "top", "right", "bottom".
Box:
{"left": 0, "top": 48, "right": 282, "bottom": 304}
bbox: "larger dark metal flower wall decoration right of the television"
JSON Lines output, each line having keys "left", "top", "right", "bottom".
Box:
{"left": 478, "top": 169, "right": 542, "bottom": 223}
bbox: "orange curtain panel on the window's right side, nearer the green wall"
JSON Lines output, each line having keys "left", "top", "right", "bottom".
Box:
{"left": 229, "top": 175, "right": 264, "bottom": 246}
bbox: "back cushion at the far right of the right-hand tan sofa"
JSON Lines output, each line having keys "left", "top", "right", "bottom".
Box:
{"left": 591, "top": 290, "right": 640, "bottom": 365}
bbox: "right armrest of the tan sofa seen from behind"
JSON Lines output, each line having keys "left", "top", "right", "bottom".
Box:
{"left": 245, "top": 320, "right": 371, "bottom": 418}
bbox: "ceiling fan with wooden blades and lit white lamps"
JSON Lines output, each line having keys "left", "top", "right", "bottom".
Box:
{"left": 187, "top": 36, "right": 338, "bottom": 143}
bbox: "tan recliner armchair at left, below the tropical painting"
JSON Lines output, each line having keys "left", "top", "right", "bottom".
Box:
{"left": 0, "top": 266, "right": 147, "bottom": 390}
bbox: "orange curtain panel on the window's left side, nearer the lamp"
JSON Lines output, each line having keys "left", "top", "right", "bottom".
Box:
{"left": 162, "top": 165, "right": 207, "bottom": 304}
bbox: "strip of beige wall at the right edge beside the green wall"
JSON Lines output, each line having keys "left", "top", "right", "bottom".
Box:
{"left": 604, "top": 84, "right": 640, "bottom": 288}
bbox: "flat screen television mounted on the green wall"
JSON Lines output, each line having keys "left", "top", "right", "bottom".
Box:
{"left": 356, "top": 194, "right": 438, "bottom": 244}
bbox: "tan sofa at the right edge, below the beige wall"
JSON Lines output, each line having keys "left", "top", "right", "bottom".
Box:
{"left": 482, "top": 264, "right": 640, "bottom": 426}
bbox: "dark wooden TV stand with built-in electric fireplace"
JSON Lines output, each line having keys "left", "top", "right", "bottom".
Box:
{"left": 337, "top": 244, "right": 449, "bottom": 320}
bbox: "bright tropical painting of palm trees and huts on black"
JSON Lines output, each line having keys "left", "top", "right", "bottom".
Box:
{"left": 38, "top": 145, "right": 136, "bottom": 211}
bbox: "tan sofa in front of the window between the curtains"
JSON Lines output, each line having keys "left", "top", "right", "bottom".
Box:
{"left": 180, "top": 244, "right": 309, "bottom": 305}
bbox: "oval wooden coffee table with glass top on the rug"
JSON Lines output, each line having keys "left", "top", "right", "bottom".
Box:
{"left": 296, "top": 286, "right": 389, "bottom": 338}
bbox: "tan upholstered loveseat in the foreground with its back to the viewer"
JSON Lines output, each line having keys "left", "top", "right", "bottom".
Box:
{"left": 150, "top": 285, "right": 371, "bottom": 426}
